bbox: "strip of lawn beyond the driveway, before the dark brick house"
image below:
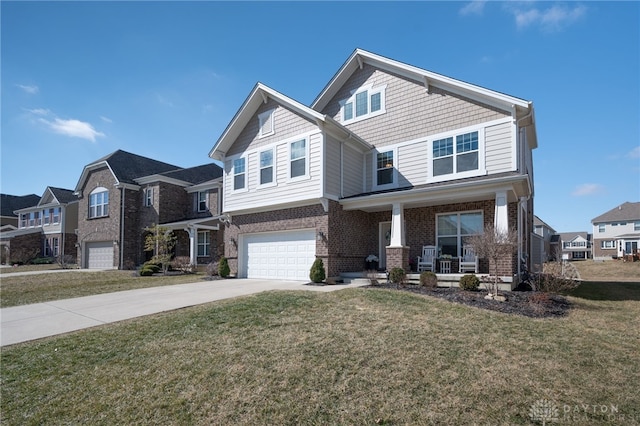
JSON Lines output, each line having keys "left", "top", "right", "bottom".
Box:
{"left": 0, "top": 270, "right": 204, "bottom": 308}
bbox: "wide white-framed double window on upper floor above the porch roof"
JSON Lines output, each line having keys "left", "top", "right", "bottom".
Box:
{"left": 433, "top": 132, "right": 479, "bottom": 176}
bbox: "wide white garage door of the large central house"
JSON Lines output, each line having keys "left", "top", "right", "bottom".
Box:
{"left": 242, "top": 230, "right": 316, "bottom": 281}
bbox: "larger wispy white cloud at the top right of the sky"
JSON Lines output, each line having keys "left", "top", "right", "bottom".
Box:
{"left": 506, "top": 3, "right": 587, "bottom": 32}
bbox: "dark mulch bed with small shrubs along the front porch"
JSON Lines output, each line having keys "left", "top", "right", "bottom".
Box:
{"left": 363, "top": 283, "right": 571, "bottom": 318}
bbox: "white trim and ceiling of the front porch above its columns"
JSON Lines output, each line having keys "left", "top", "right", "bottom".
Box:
{"left": 340, "top": 175, "right": 531, "bottom": 212}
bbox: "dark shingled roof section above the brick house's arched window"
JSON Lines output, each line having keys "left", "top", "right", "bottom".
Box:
{"left": 90, "top": 149, "right": 181, "bottom": 184}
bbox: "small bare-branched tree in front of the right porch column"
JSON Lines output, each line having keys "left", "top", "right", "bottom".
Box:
{"left": 465, "top": 225, "right": 518, "bottom": 297}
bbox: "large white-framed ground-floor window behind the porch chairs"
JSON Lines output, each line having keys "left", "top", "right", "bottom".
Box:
{"left": 436, "top": 212, "right": 483, "bottom": 257}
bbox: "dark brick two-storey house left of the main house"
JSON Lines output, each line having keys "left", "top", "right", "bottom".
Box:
{"left": 75, "top": 150, "right": 222, "bottom": 269}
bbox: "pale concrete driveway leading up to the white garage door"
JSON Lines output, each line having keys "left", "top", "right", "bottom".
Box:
{"left": 0, "top": 279, "right": 358, "bottom": 346}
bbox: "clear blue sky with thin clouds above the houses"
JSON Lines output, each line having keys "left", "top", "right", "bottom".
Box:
{"left": 0, "top": 1, "right": 640, "bottom": 232}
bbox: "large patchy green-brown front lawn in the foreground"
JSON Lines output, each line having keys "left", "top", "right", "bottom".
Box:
{"left": 0, "top": 289, "right": 640, "bottom": 425}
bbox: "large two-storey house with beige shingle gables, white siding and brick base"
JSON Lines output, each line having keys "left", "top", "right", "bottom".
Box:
{"left": 209, "top": 49, "right": 537, "bottom": 285}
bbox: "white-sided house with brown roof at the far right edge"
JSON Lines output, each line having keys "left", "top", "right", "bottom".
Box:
{"left": 591, "top": 202, "right": 640, "bottom": 259}
